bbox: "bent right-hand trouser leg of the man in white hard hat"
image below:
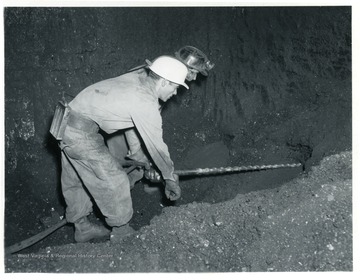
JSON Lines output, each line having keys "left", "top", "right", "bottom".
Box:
{"left": 64, "top": 134, "right": 133, "bottom": 226}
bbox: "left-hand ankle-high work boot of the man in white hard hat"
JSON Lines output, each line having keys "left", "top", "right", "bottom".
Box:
{"left": 74, "top": 217, "right": 110, "bottom": 243}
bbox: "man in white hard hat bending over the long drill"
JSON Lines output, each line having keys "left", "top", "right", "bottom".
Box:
{"left": 54, "top": 46, "right": 214, "bottom": 243}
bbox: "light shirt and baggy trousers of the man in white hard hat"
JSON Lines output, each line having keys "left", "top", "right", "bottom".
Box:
{"left": 60, "top": 70, "right": 175, "bottom": 226}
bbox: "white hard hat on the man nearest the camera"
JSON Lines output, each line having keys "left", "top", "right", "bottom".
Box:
{"left": 146, "top": 55, "right": 189, "bottom": 89}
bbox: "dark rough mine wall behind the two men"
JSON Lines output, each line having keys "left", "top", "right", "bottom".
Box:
{"left": 4, "top": 7, "right": 352, "bottom": 252}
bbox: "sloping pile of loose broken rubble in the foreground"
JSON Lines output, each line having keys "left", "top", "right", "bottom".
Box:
{"left": 6, "top": 152, "right": 352, "bottom": 272}
